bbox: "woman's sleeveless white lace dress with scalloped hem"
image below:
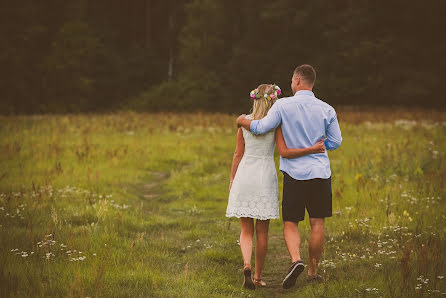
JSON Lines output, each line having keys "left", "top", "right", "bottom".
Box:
{"left": 226, "top": 116, "right": 280, "bottom": 220}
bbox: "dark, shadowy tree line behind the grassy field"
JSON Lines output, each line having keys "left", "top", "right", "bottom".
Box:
{"left": 0, "top": 0, "right": 446, "bottom": 114}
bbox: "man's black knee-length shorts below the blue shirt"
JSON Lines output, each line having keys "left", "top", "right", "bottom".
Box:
{"left": 282, "top": 172, "right": 332, "bottom": 222}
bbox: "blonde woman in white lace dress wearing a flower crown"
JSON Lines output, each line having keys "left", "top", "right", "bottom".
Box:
{"left": 226, "top": 84, "right": 325, "bottom": 289}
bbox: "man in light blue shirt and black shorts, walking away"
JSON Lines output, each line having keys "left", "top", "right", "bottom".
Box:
{"left": 237, "top": 64, "right": 342, "bottom": 289}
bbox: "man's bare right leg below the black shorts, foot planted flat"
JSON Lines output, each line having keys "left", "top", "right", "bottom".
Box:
{"left": 308, "top": 218, "right": 324, "bottom": 276}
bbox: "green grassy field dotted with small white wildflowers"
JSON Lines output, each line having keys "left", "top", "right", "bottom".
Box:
{"left": 0, "top": 109, "right": 446, "bottom": 297}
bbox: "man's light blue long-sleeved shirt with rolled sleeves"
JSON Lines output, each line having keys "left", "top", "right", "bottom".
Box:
{"left": 251, "top": 90, "right": 342, "bottom": 180}
